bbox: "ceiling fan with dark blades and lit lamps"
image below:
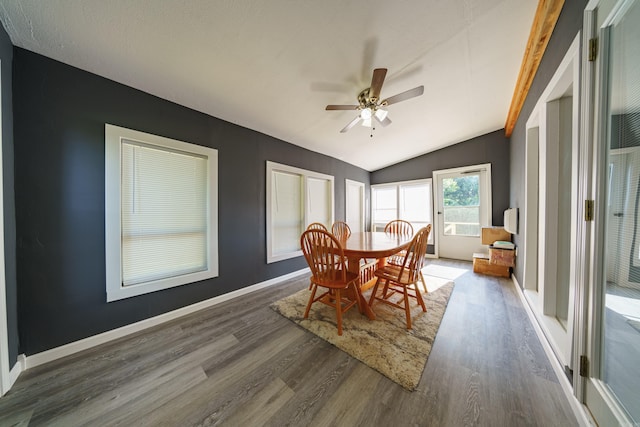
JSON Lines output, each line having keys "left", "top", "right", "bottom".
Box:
{"left": 325, "top": 68, "right": 424, "bottom": 133}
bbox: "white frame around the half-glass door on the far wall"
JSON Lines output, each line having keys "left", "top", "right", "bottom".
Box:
{"left": 432, "top": 163, "right": 493, "bottom": 261}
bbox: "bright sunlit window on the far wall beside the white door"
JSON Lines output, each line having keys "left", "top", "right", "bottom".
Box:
{"left": 371, "top": 179, "right": 433, "bottom": 244}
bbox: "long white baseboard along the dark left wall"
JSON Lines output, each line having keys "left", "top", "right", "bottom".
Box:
{"left": 20, "top": 268, "right": 309, "bottom": 372}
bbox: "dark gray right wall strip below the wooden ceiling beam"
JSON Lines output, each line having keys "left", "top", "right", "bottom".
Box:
{"left": 509, "top": 0, "right": 587, "bottom": 285}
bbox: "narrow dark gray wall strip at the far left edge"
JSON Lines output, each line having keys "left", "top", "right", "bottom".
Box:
{"left": 0, "top": 20, "right": 19, "bottom": 366}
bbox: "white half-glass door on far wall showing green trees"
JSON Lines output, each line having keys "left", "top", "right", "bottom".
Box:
{"left": 433, "top": 164, "right": 491, "bottom": 261}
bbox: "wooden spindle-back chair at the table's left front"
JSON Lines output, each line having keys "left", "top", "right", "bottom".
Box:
{"left": 300, "top": 230, "right": 362, "bottom": 335}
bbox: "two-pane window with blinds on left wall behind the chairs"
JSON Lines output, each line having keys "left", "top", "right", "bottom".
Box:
{"left": 266, "top": 162, "right": 334, "bottom": 263}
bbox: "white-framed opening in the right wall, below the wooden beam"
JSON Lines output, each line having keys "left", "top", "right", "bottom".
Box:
{"left": 522, "top": 35, "right": 580, "bottom": 369}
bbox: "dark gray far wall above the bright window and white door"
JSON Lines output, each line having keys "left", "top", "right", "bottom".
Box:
{"left": 371, "top": 130, "right": 509, "bottom": 225}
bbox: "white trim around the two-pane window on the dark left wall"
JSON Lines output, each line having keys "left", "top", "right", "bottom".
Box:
{"left": 266, "top": 160, "right": 335, "bottom": 264}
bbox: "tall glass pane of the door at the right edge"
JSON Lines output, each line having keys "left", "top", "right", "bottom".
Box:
{"left": 601, "top": 1, "right": 640, "bottom": 423}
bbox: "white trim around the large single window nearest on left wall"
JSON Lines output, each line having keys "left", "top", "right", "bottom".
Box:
{"left": 105, "top": 123, "right": 218, "bottom": 302}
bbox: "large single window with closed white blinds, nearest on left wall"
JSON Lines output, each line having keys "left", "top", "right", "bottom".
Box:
{"left": 105, "top": 124, "right": 218, "bottom": 301}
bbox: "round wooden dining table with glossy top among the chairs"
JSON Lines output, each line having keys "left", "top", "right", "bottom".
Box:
{"left": 340, "top": 231, "right": 412, "bottom": 320}
